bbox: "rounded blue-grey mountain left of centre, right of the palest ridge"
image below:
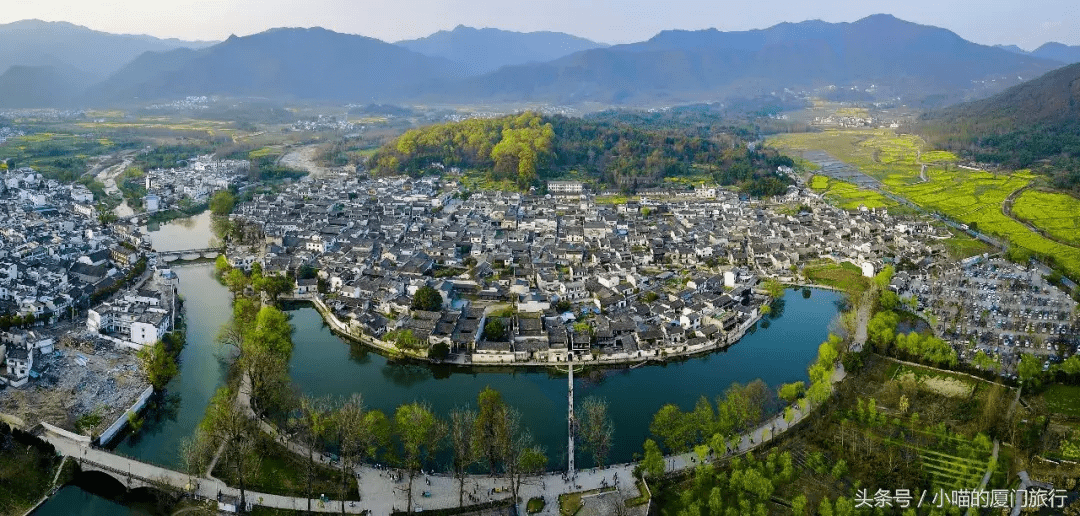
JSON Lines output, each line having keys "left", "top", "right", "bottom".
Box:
{"left": 90, "top": 28, "right": 462, "bottom": 104}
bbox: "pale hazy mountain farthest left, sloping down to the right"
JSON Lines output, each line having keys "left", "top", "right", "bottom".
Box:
{"left": 0, "top": 19, "right": 213, "bottom": 79}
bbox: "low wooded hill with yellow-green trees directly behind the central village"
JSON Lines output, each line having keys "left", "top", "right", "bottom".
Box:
{"left": 368, "top": 112, "right": 792, "bottom": 196}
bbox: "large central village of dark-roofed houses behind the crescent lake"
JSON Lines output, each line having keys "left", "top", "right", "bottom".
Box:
{"left": 228, "top": 171, "right": 945, "bottom": 364}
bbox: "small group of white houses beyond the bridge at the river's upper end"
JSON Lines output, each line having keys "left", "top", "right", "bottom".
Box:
{"left": 143, "top": 154, "right": 251, "bottom": 213}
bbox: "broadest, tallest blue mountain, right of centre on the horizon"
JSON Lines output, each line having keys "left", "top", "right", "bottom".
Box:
{"left": 441, "top": 15, "right": 1056, "bottom": 104}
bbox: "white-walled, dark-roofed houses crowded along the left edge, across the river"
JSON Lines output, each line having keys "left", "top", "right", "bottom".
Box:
{"left": 0, "top": 167, "right": 154, "bottom": 386}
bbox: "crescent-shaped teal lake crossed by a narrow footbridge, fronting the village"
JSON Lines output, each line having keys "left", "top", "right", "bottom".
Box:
{"left": 289, "top": 290, "right": 840, "bottom": 469}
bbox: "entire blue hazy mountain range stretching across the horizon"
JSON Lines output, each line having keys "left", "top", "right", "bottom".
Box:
{"left": 0, "top": 15, "right": 1061, "bottom": 106}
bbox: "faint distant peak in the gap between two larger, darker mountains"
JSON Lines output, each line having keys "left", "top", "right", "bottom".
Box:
{"left": 394, "top": 25, "right": 607, "bottom": 74}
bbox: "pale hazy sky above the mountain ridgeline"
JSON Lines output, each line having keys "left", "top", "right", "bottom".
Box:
{"left": 0, "top": 0, "right": 1080, "bottom": 50}
